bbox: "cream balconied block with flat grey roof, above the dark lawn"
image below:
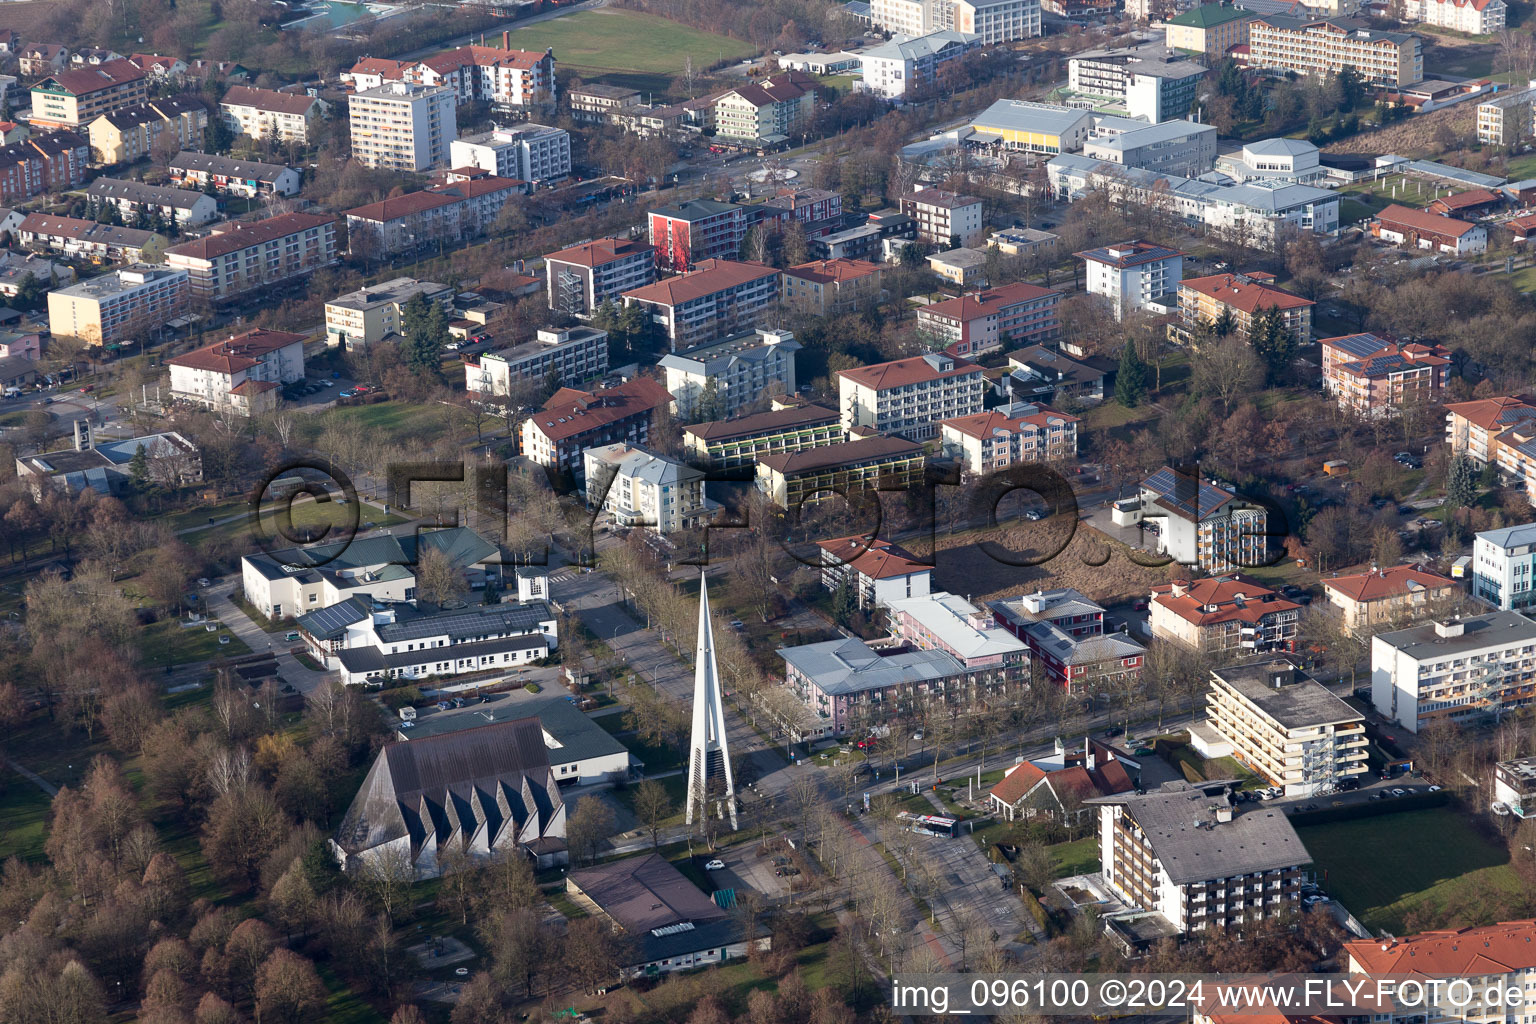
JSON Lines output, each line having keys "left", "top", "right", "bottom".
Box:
{"left": 1206, "top": 659, "right": 1367, "bottom": 797}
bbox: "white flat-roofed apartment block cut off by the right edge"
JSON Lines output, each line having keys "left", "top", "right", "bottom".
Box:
{"left": 1370, "top": 611, "right": 1536, "bottom": 732}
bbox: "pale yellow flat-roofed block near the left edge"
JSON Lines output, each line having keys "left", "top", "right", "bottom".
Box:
{"left": 48, "top": 264, "right": 189, "bottom": 347}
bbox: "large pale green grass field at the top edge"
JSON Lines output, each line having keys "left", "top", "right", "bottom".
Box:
{"left": 511, "top": 9, "right": 754, "bottom": 78}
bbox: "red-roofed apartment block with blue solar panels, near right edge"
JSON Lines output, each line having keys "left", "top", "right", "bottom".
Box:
{"left": 1319, "top": 333, "right": 1450, "bottom": 419}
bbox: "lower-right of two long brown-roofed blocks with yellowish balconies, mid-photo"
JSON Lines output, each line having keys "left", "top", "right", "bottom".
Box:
{"left": 757, "top": 438, "right": 928, "bottom": 508}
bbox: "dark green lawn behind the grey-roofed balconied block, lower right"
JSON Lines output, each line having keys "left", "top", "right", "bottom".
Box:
{"left": 1296, "top": 808, "right": 1521, "bottom": 933}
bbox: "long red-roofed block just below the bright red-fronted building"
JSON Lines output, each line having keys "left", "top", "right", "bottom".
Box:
{"left": 624, "top": 259, "right": 779, "bottom": 352}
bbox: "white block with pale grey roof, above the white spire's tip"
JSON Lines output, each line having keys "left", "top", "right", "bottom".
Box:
{"left": 584, "top": 444, "right": 714, "bottom": 536}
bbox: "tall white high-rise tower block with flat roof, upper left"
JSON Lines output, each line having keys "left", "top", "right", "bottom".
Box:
{"left": 347, "top": 81, "right": 459, "bottom": 170}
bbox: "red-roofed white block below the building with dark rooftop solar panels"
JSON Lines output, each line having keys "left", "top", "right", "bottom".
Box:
{"left": 1149, "top": 574, "right": 1301, "bottom": 657}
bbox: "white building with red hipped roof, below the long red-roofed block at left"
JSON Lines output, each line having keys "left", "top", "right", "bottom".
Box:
{"left": 166, "top": 327, "right": 304, "bottom": 416}
